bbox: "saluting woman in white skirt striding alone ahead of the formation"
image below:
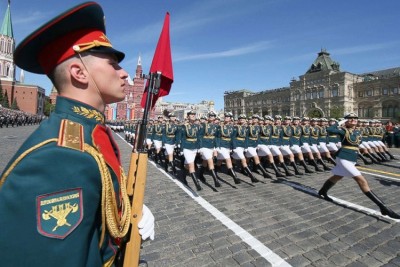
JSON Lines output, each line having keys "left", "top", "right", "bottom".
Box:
{"left": 318, "top": 113, "right": 400, "bottom": 219}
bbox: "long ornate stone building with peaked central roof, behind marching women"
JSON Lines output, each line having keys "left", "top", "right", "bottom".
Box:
{"left": 224, "top": 50, "right": 400, "bottom": 120}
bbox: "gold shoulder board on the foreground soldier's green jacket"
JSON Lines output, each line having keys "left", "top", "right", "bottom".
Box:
{"left": 57, "top": 119, "right": 85, "bottom": 152}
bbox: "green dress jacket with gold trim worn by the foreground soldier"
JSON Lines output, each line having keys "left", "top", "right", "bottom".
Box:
{"left": 0, "top": 97, "right": 125, "bottom": 267}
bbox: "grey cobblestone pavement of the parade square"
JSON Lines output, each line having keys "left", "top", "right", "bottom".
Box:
{"left": 0, "top": 126, "right": 400, "bottom": 267}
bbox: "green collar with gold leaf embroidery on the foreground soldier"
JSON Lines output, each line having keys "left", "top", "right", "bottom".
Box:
{"left": 55, "top": 96, "right": 105, "bottom": 124}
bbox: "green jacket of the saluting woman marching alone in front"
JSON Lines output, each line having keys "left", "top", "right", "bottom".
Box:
{"left": 327, "top": 124, "right": 361, "bottom": 162}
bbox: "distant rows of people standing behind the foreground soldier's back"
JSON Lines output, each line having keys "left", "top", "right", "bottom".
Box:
{"left": 0, "top": 107, "right": 44, "bottom": 128}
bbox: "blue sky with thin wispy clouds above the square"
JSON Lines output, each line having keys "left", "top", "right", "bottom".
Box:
{"left": 4, "top": 0, "right": 400, "bottom": 109}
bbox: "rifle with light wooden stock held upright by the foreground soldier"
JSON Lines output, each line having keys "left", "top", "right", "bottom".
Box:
{"left": 116, "top": 72, "right": 161, "bottom": 267}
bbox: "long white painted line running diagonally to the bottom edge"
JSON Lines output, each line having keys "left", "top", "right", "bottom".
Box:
{"left": 117, "top": 134, "right": 292, "bottom": 267}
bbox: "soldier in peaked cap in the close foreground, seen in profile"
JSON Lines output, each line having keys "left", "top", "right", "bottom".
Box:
{"left": 0, "top": 2, "right": 154, "bottom": 267}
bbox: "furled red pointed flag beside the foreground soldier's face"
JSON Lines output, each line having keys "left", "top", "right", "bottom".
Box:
{"left": 141, "top": 12, "right": 174, "bottom": 109}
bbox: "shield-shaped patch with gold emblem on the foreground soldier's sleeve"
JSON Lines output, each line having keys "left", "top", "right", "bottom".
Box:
{"left": 36, "top": 188, "right": 83, "bottom": 239}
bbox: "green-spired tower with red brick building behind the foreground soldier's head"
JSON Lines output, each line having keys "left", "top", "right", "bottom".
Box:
{"left": 0, "top": 1, "right": 46, "bottom": 115}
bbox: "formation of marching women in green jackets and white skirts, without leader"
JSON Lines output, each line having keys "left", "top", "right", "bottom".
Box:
{"left": 109, "top": 110, "right": 395, "bottom": 193}
